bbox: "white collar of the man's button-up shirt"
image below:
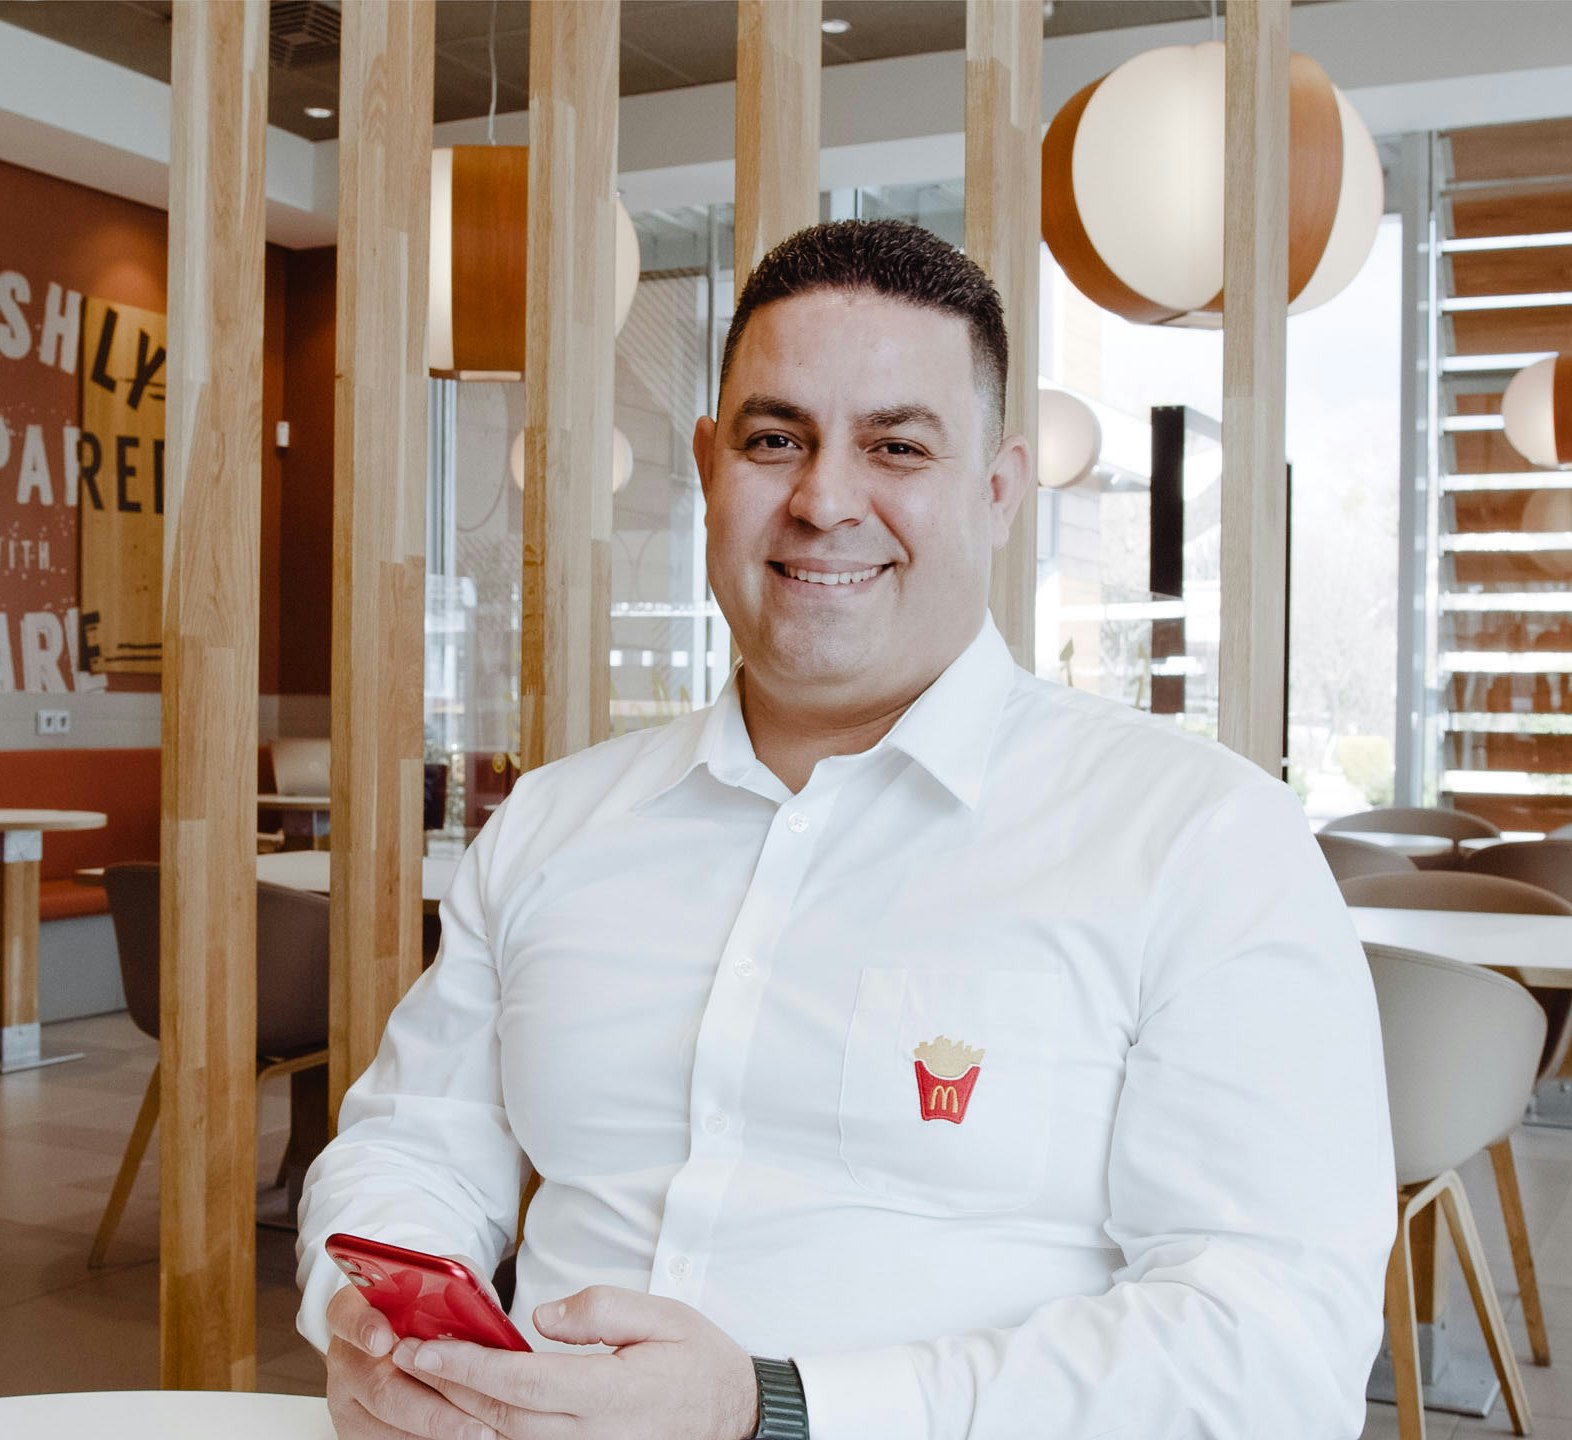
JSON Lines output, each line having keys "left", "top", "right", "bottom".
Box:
{"left": 645, "top": 615, "right": 1016, "bottom": 810}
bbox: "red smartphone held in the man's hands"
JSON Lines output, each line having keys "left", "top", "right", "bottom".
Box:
{"left": 324, "top": 1234, "right": 530, "bottom": 1350}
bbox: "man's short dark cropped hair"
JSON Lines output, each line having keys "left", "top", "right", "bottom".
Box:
{"left": 720, "top": 220, "right": 1009, "bottom": 443}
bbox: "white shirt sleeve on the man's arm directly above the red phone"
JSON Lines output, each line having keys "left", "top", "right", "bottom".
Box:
{"left": 296, "top": 827, "right": 527, "bottom": 1350}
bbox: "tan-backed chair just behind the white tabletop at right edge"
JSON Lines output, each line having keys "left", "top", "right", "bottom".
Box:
{"left": 1338, "top": 869, "right": 1572, "bottom": 1365}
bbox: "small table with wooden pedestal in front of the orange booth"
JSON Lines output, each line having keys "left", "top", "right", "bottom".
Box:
{"left": 0, "top": 810, "right": 108, "bottom": 1074}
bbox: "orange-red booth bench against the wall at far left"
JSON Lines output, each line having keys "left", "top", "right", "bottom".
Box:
{"left": 0, "top": 747, "right": 160, "bottom": 920}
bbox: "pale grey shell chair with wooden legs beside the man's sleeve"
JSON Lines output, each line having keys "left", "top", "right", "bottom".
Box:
{"left": 1364, "top": 945, "right": 1545, "bottom": 1440}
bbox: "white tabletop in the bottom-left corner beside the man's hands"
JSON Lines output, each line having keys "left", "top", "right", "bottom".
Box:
{"left": 0, "top": 1390, "right": 333, "bottom": 1440}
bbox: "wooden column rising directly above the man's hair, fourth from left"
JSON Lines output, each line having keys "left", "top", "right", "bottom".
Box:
{"left": 733, "top": 0, "right": 824, "bottom": 294}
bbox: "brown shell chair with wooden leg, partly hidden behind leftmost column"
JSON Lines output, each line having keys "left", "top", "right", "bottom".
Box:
{"left": 88, "top": 865, "right": 329, "bottom": 1267}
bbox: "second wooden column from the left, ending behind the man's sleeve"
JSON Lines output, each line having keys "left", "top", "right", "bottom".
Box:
{"left": 329, "top": 0, "right": 435, "bottom": 1116}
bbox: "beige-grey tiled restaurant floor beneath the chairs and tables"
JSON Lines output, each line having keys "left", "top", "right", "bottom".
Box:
{"left": 9, "top": 1016, "right": 1572, "bottom": 1440}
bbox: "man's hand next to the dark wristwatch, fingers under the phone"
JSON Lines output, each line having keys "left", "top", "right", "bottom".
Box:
{"left": 385, "top": 1286, "right": 759, "bottom": 1440}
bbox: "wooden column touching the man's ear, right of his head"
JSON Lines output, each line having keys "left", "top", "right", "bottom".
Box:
{"left": 965, "top": 0, "right": 1042, "bottom": 670}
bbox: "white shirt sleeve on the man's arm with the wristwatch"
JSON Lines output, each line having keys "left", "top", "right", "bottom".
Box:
{"left": 795, "top": 783, "right": 1396, "bottom": 1440}
